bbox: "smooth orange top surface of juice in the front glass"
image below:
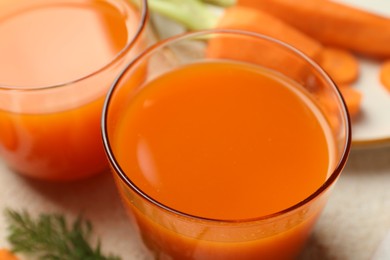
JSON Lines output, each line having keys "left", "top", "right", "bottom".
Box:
{"left": 112, "top": 62, "right": 331, "bottom": 220}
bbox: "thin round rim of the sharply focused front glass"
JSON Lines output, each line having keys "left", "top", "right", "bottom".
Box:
{"left": 101, "top": 29, "right": 352, "bottom": 224}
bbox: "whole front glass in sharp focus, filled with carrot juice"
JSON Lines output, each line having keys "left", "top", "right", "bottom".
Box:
{"left": 102, "top": 31, "right": 351, "bottom": 260}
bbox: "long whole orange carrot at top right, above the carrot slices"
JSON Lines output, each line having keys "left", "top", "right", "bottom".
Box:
{"left": 238, "top": 0, "right": 390, "bottom": 58}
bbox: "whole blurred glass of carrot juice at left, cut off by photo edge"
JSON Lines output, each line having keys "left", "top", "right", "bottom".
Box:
{"left": 0, "top": 0, "right": 147, "bottom": 181}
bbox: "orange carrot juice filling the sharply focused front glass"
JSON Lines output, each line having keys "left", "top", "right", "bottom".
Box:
{"left": 111, "top": 62, "right": 334, "bottom": 259}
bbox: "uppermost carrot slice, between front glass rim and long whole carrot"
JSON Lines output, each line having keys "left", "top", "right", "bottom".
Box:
{"left": 319, "top": 47, "right": 359, "bottom": 84}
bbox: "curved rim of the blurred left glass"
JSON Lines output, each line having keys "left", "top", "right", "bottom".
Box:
{"left": 0, "top": 0, "right": 149, "bottom": 92}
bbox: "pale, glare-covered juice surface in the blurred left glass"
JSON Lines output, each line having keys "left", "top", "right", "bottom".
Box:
{"left": 0, "top": 1, "right": 128, "bottom": 87}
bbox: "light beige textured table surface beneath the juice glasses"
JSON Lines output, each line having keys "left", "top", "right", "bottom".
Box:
{"left": 0, "top": 145, "right": 390, "bottom": 260}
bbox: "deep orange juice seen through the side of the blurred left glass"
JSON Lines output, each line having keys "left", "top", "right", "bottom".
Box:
{"left": 0, "top": 99, "right": 107, "bottom": 181}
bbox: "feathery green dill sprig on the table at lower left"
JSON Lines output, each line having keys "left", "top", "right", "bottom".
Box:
{"left": 5, "top": 210, "right": 120, "bottom": 260}
